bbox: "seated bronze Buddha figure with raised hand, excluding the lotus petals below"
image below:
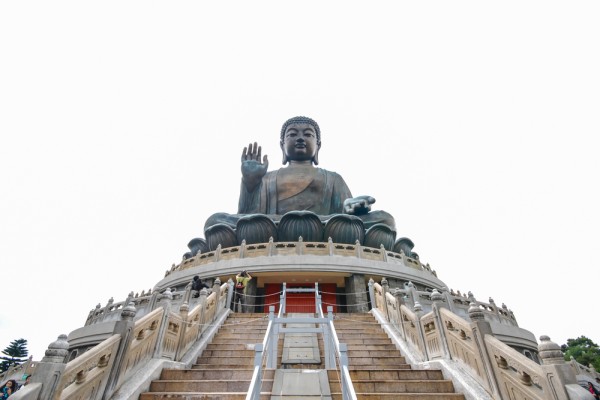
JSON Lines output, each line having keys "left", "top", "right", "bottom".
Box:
{"left": 205, "top": 117, "right": 395, "bottom": 230}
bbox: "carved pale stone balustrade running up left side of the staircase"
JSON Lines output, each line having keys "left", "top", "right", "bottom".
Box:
{"left": 11, "top": 280, "right": 233, "bottom": 400}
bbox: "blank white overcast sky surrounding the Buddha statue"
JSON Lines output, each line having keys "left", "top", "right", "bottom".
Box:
{"left": 0, "top": 1, "right": 600, "bottom": 360}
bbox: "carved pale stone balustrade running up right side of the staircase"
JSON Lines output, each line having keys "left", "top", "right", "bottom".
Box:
{"left": 369, "top": 278, "right": 595, "bottom": 400}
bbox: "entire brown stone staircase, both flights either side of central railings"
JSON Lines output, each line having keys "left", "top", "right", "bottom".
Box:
{"left": 139, "top": 313, "right": 465, "bottom": 400}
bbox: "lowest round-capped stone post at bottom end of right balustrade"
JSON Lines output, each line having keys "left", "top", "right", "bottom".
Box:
{"left": 538, "top": 335, "right": 589, "bottom": 400}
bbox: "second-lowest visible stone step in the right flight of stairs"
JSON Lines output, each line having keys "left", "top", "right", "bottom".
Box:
{"left": 329, "top": 380, "right": 454, "bottom": 393}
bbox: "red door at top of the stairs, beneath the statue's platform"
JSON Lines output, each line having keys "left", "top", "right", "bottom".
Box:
{"left": 265, "top": 283, "right": 337, "bottom": 314}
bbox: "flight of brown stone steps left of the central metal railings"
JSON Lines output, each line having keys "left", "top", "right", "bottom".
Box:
{"left": 139, "top": 313, "right": 274, "bottom": 400}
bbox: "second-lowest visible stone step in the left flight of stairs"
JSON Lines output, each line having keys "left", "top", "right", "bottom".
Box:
{"left": 150, "top": 379, "right": 273, "bottom": 393}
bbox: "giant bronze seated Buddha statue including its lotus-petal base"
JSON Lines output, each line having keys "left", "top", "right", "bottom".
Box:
{"left": 188, "top": 117, "right": 412, "bottom": 254}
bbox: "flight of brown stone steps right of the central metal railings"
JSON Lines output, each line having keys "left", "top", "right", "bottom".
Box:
{"left": 328, "top": 313, "right": 465, "bottom": 400}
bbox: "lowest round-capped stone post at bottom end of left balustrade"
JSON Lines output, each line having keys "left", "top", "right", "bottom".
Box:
{"left": 31, "top": 334, "right": 69, "bottom": 399}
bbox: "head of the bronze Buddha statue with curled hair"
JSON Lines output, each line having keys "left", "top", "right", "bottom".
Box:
{"left": 279, "top": 117, "right": 321, "bottom": 165}
